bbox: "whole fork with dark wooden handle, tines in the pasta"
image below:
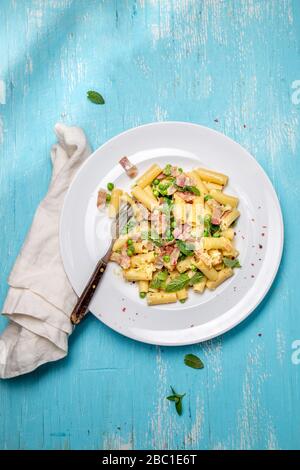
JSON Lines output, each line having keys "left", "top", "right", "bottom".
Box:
{"left": 70, "top": 203, "right": 132, "bottom": 325}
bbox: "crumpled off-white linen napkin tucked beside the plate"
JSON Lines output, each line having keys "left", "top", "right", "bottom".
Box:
{"left": 0, "top": 124, "right": 91, "bottom": 378}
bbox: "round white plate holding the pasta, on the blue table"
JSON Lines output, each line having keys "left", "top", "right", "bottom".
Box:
{"left": 60, "top": 122, "right": 283, "bottom": 346}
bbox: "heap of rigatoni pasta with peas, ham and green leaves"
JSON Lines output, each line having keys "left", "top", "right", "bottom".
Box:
{"left": 101, "top": 164, "right": 240, "bottom": 305}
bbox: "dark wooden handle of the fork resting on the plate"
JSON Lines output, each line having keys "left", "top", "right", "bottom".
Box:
{"left": 71, "top": 259, "right": 107, "bottom": 325}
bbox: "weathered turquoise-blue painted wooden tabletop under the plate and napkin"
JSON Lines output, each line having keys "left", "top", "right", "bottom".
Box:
{"left": 0, "top": 0, "right": 300, "bottom": 449}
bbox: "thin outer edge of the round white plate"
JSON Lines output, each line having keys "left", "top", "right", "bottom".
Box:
{"left": 59, "top": 121, "right": 284, "bottom": 347}
